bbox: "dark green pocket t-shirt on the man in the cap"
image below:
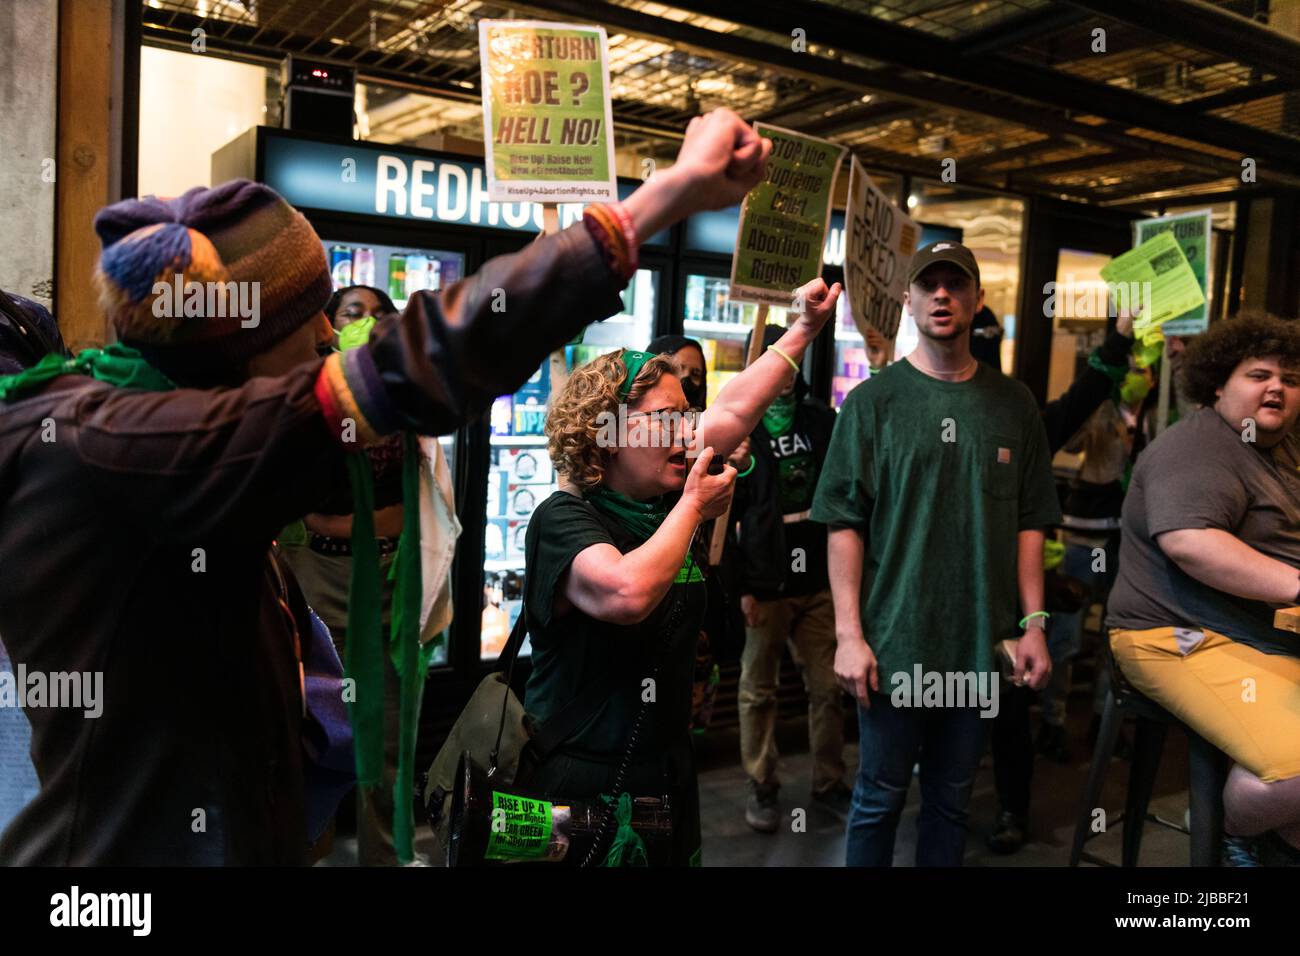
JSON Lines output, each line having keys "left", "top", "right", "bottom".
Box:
{"left": 813, "top": 360, "right": 1061, "bottom": 693}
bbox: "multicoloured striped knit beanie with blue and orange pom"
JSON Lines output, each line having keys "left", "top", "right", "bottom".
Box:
{"left": 95, "top": 179, "right": 330, "bottom": 381}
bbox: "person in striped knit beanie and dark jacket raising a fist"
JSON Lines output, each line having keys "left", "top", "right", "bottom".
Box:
{"left": 0, "top": 111, "right": 771, "bottom": 865}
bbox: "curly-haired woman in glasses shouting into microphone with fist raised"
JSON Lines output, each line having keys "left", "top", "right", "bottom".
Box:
{"left": 524, "top": 278, "right": 840, "bottom": 865}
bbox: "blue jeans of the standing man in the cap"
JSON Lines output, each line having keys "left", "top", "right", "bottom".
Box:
{"left": 846, "top": 693, "right": 992, "bottom": 866}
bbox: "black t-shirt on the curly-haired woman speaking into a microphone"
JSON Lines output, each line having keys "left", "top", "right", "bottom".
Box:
{"left": 524, "top": 492, "right": 707, "bottom": 760}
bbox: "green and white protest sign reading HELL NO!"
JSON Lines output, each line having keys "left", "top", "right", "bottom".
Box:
{"left": 478, "top": 20, "right": 618, "bottom": 203}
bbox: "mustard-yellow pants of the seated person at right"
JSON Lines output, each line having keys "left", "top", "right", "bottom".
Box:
{"left": 1110, "top": 627, "right": 1300, "bottom": 782}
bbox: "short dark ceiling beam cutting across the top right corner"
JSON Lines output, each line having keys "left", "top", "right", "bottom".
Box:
{"left": 1070, "top": 0, "right": 1300, "bottom": 82}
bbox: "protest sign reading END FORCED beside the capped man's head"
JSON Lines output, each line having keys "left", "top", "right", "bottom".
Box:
{"left": 844, "top": 156, "right": 920, "bottom": 341}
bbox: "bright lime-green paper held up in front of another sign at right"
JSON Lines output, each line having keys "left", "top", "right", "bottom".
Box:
{"left": 1101, "top": 232, "right": 1205, "bottom": 336}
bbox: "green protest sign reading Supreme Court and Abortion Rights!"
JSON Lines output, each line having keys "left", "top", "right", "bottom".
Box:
{"left": 728, "top": 122, "right": 848, "bottom": 308}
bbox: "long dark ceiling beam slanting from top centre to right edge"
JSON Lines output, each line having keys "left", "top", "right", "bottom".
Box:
{"left": 660, "top": 0, "right": 1300, "bottom": 172}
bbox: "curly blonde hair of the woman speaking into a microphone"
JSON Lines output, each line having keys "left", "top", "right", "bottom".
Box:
{"left": 546, "top": 350, "right": 677, "bottom": 492}
